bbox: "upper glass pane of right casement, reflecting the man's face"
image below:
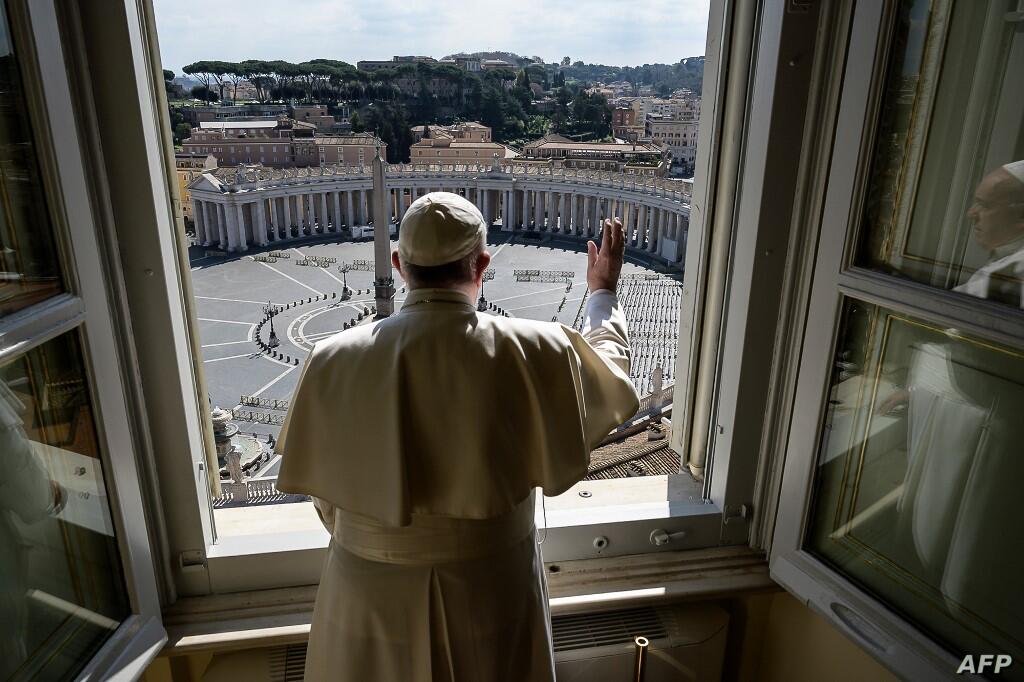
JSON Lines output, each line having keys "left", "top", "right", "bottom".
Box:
{"left": 857, "top": 0, "right": 1024, "bottom": 307}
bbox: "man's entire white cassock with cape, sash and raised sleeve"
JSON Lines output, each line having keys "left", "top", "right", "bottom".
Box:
{"left": 278, "top": 289, "right": 639, "bottom": 682}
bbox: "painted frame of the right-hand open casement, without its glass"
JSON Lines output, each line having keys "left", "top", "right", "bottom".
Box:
{"left": 769, "top": 0, "right": 1024, "bottom": 679}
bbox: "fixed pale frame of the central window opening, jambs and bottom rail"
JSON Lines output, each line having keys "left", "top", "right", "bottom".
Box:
{"left": 99, "top": 0, "right": 798, "bottom": 596}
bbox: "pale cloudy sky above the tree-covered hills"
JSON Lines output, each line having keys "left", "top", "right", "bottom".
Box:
{"left": 154, "top": 0, "right": 709, "bottom": 76}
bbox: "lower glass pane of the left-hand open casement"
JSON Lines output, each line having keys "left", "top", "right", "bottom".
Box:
{"left": 0, "top": 333, "right": 130, "bottom": 680}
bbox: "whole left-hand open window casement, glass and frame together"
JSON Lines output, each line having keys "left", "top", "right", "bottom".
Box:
{"left": 0, "top": 0, "right": 166, "bottom": 679}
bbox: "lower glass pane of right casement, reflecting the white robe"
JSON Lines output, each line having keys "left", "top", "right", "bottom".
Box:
{"left": 807, "top": 301, "right": 1024, "bottom": 667}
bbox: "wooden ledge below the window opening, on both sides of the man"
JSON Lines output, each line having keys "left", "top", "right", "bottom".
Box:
{"left": 161, "top": 534, "right": 778, "bottom": 655}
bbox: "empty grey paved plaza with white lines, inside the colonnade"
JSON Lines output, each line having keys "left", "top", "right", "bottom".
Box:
{"left": 191, "top": 231, "right": 679, "bottom": 450}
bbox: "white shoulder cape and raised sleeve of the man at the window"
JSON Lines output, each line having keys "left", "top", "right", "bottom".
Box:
{"left": 278, "top": 289, "right": 639, "bottom": 526}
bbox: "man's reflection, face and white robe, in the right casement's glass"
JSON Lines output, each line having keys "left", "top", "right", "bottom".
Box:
{"left": 878, "top": 162, "right": 1024, "bottom": 650}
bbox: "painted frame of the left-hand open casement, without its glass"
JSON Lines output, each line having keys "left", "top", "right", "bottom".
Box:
{"left": 0, "top": 0, "right": 167, "bottom": 679}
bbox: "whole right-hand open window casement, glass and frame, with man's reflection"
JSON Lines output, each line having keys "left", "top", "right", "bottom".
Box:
{"left": 771, "top": 0, "right": 1024, "bottom": 679}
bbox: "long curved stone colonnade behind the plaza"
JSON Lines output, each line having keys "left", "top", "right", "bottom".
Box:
{"left": 190, "top": 163, "right": 693, "bottom": 267}
